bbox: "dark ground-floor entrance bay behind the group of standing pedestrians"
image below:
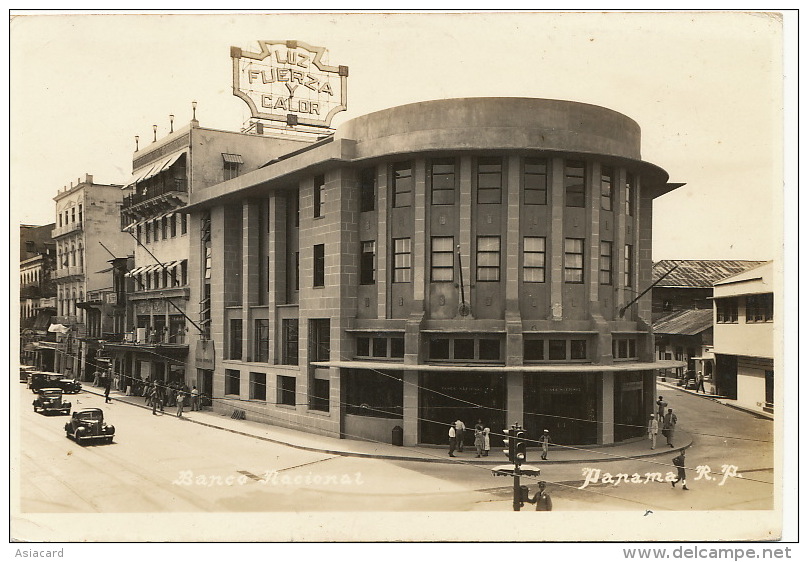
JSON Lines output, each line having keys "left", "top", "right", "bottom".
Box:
{"left": 418, "top": 372, "right": 505, "bottom": 444}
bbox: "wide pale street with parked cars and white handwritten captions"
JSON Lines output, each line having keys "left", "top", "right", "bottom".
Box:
{"left": 19, "top": 385, "right": 774, "bottom": 513}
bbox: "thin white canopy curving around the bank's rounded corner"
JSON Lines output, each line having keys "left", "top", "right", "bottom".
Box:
{"left": 312, "top": 361, "right": 687, "bottom": 373}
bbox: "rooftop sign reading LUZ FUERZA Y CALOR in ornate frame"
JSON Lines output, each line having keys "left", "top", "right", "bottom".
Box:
{"left": 230, "top": 41, "right": 348, "bottom": 127}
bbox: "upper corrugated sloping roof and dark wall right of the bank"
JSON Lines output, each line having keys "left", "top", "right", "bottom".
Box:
{"left": 652, "top": 260, "right": 764, "bottom": 322}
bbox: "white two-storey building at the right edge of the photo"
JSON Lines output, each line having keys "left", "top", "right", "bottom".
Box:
{"left": 714, "top": 262, "right": 775, "bottom": 413}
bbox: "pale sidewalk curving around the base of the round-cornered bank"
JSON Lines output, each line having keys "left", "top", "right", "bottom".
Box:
{"left": 88, "top": 385, "right": 693, "bottom": 468}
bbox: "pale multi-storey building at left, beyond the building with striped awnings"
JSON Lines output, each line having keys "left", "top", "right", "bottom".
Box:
{"left": 53, "top": 174, "right": 131, "bottom": 380}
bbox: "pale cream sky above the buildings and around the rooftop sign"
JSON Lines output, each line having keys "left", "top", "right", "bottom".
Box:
{"left": 9, "top": 12, "right": 784, "bottom": 260}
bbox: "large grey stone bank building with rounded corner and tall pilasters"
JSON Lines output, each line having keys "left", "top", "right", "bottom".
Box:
{"left": 186, "top": 98, "right": 681, "bottom": 444}
